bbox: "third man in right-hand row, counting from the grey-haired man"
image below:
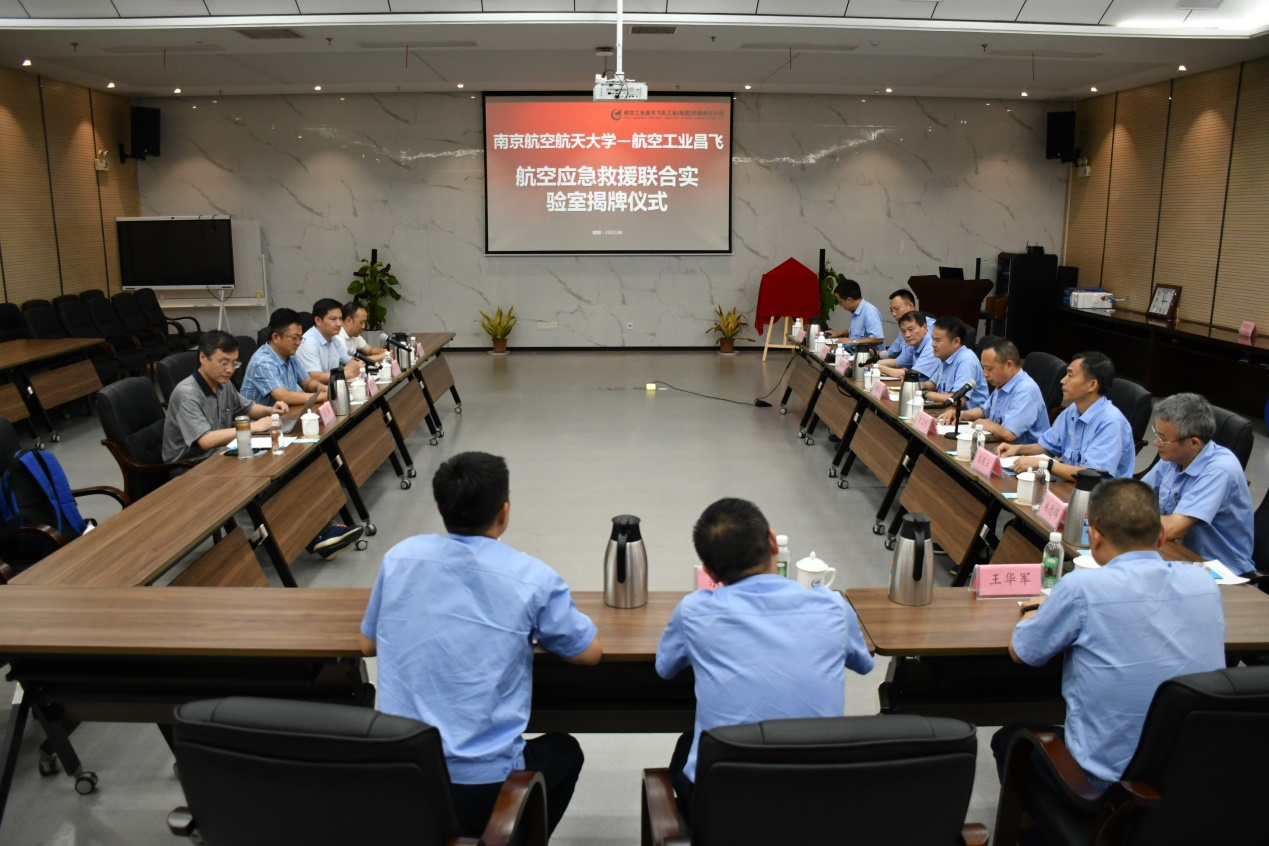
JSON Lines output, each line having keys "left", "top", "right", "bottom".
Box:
{"left": 939, "top": 337, "right": 1048, "bottom": 444}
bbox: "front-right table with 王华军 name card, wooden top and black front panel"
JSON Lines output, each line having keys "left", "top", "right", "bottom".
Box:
{"left": 846, "top": 586, "right": 1269, "bottom": 726}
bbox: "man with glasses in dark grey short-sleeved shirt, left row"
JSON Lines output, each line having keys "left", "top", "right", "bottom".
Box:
{"left": 162, "top": 331, "right": 288, "bottom": 462}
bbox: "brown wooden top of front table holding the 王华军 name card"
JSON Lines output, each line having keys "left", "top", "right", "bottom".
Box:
{"left": 846, "top": 586, "right": 1269, "bottom": 657}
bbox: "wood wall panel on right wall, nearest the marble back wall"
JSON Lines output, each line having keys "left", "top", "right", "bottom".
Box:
{"left": 1063, "top": 94, "right": 1114, "bottom": 287}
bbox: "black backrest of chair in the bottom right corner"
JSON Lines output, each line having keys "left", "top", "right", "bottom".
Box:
{"left": 1121, "top": 666, "right": 1269, "bottom": 845}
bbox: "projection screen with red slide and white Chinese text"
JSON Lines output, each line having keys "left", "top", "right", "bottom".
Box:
{"left": 485, "top": 95, "right": 731, "bottom": 252}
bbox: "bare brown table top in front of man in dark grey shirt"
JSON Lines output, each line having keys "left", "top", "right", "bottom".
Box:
{"left": 13, "top": 474, "right": 269, "bottom": 587}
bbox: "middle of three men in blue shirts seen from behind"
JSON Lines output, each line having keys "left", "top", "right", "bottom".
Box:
{"left": 656, "top": 498, "right": 873, "bottom": 816}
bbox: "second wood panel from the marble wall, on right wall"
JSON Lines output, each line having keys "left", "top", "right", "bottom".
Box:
{"left": 1101, "top": 81, "right": 1167, "bottom": 309}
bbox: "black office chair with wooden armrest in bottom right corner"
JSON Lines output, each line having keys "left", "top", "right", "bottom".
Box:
{"left": 994, "top": 667, "right": 1269, "bottom": 846}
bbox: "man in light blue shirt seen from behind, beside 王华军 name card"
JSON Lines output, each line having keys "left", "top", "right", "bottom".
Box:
{"left": 991, "top": 479, "right": 1225, "bottom": 789}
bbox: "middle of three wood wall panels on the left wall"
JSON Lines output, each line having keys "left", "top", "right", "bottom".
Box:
{"left": 41, "top": 79, "right": 105, "bottom": 294}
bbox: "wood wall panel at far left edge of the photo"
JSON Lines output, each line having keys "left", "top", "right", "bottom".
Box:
{"left": 0, "top": 68, "right": 61, "bottom": 303}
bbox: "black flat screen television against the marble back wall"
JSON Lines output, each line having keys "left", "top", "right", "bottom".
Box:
{"left": 115, "top": 214, "right": 233, "bottom": 290}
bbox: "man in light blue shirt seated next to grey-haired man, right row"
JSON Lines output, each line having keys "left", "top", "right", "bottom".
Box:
{"left": 996, "top": 353, "right": 1137, "bottom": 482}
